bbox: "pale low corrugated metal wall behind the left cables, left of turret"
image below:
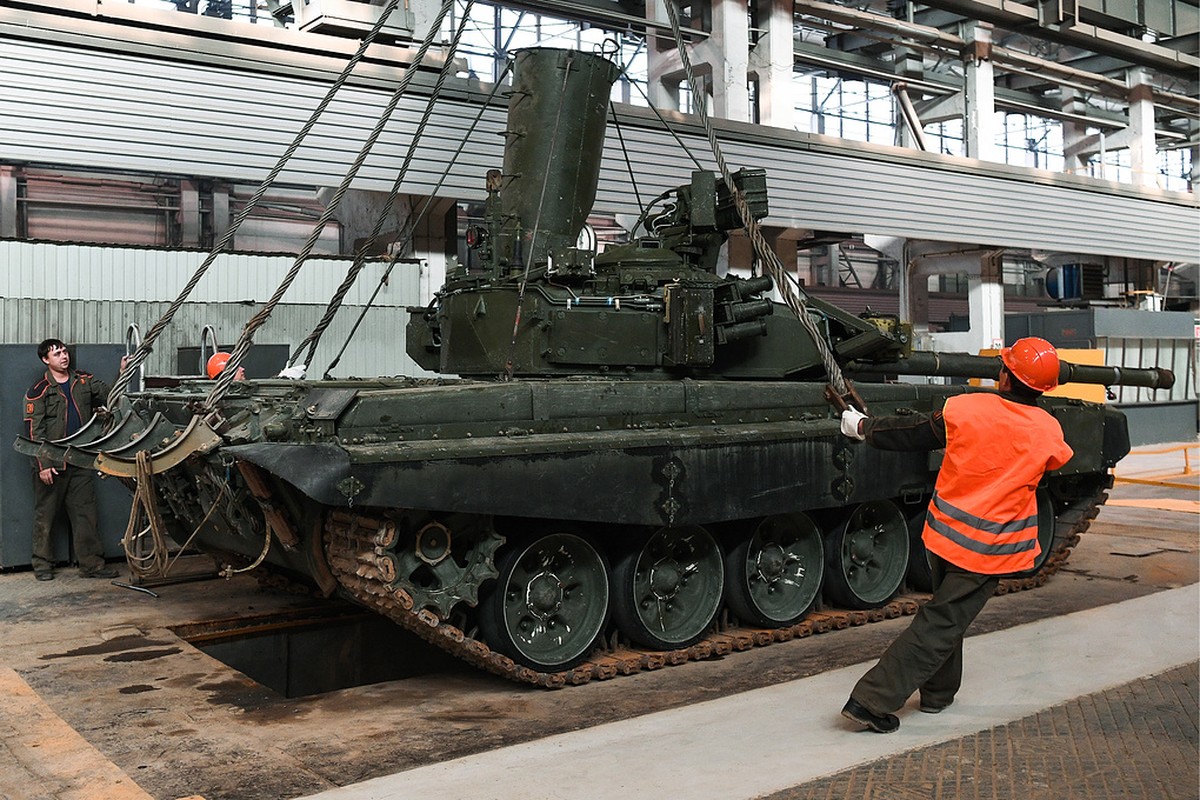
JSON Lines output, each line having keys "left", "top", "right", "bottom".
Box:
{"left": 0, "top": 241, "right": 424, "bottom": 377}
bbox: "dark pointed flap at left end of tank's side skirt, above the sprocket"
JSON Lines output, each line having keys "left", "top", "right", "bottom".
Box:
{"left": 222, "top": 443, "right": 355, "bottom": 506}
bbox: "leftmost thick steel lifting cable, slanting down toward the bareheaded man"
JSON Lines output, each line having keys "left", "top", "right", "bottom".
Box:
{"left": 107, "top": 0, "right": 401, "bottom": 408}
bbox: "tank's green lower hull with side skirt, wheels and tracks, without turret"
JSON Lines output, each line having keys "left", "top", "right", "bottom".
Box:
{"left": 46, "top": 379, "right": 1128, "bottom": 686}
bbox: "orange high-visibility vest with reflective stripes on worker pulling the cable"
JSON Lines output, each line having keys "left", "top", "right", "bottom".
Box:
{"left": 922, "top": 392, "right": 1074, "bottom": 575}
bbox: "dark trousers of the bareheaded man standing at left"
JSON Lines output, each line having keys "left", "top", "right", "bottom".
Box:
{"left": 32, "top": 465, "right": 104, "bottom": 573}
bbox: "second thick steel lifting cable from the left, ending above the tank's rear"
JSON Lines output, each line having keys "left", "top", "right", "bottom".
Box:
{"left": 202, "top": 0, "right": 455, "bottom": 417}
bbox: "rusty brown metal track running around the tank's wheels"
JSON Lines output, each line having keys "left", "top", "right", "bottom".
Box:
{"left": 316, "top": 477, "right": 1112, "bottom": 688}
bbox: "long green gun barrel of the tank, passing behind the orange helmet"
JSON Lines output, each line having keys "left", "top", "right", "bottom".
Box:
{"left": 846, "top": 351, "right": 1175, "bottom": 389}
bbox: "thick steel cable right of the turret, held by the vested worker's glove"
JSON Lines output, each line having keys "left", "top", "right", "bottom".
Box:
{"left": 664, "top": 0, "right": 848, "bottom": 395}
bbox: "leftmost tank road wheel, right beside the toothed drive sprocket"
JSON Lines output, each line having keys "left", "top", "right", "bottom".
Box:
{"left": 479, "top": 533, "right": 608, "bottom": 672}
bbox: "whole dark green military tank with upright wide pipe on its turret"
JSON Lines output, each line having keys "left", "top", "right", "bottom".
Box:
{"left": 17, "top": 49, "right": 1174, "bottom": 686}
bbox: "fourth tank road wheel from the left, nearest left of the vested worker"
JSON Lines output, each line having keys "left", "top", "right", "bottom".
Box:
{"left": 824, "top": 500, "right": 908, "bottom": 609}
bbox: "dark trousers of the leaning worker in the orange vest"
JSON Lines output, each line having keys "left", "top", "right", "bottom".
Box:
{"left": 850, "top": 553, "right": 1000, "bottom": 714}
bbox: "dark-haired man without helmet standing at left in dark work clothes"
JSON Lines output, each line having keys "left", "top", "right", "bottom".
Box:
{"left": 25, "top": 339, "right": 116, "bottom": 581}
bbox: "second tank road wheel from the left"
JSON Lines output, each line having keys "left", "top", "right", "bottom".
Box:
{"left": 612, "top": 525, "right": 725, "bottom": 650}
